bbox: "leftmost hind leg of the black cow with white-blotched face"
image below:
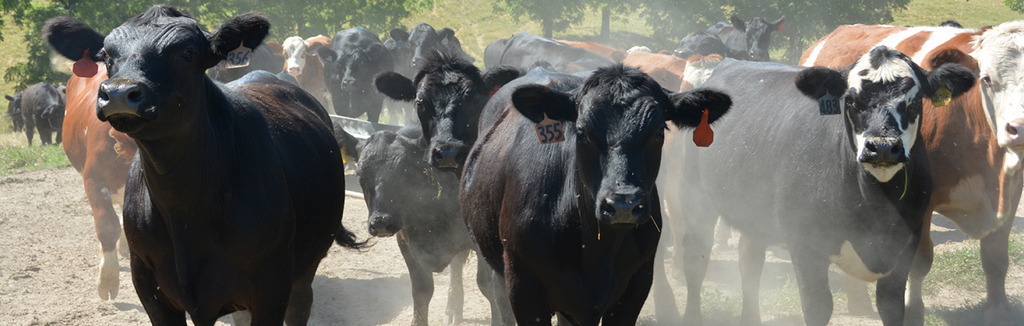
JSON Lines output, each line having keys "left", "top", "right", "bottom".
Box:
{"left": 677, "top": 214, "right": 718, "bottom": 325}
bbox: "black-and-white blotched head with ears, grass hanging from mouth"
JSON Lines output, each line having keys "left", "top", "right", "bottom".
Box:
{"left": 796, "top": 46, "right": 974, "bottom": 182}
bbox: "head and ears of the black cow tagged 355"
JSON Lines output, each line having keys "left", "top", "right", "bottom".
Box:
{"left": 512, "top": 65, "right": 731, "bottom": 229}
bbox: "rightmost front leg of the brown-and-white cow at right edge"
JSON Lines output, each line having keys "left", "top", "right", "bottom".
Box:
{"left": 981, "top": 215, "right": 1019, "bottom": 325}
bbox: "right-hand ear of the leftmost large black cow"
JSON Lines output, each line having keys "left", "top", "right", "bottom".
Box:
{"left": 207, "top": 12, "right": 270, "bottom": 68}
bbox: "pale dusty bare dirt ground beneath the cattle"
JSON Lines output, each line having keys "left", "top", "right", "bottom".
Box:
{"left": 0, "top": 167, "right": 1024, "bottom": 325}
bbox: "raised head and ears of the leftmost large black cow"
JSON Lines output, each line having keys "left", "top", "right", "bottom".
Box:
{"left": 43, "top": 5, "right": 270, "bottom": 139}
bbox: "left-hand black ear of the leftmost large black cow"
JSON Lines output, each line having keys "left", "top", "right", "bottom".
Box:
{"left": 43, "top": 16, "right": 104, "bottom": 62}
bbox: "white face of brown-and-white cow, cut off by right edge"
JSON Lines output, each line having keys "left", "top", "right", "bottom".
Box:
{"left": 971, "top": 22, "right": 1024, "bottom": 156}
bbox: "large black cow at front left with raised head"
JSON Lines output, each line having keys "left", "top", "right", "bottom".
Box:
{"left": 43, "top": 5, "right": 360, "bottom": 325}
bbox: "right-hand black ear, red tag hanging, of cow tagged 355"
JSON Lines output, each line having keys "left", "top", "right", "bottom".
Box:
{"left": 665, "top": 88, "right": 732, "bottom": 128}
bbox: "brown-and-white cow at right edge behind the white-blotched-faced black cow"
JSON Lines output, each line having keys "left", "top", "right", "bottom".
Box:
{"left": 800, "top": 21, "right": 1024, "bottom": 325}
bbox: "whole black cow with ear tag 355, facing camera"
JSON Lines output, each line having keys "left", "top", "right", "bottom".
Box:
{"left": 460, "top": 65, "right": 730, "bottom": 325}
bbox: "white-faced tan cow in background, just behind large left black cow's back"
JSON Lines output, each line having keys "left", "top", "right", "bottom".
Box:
{"left": 283, "top": 35, "right": 335, "bottom": 114}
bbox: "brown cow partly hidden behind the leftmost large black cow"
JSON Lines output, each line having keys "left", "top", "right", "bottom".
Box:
{"left": 62, "top": 65, "right": 138, "bottom": 300}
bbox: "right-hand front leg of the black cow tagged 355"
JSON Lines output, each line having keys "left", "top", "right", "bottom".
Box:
{"left": 598, "top": 255, "right": 655, "bottom": 326}
